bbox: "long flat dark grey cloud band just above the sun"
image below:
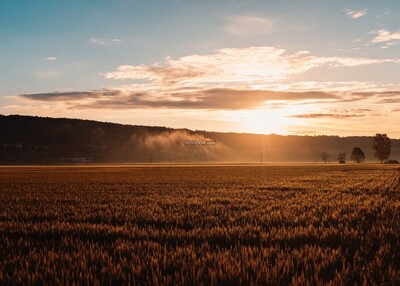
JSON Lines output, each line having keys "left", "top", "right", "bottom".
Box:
{"left": 20, "top": 89, "right": 337, "bottom": 110}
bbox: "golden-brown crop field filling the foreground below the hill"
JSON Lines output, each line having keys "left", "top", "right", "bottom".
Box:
{"left": 0, "top": 164, "right": 400, "bottom": 285}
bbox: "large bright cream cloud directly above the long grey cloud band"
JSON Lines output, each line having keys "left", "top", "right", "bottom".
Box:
{"left": 104, "top": 46, "right": 399, "bottom": 87}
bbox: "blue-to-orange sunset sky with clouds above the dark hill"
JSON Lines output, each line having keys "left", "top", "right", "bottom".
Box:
{"left": 0, "top": 0, "right": 400, "bottom": 138}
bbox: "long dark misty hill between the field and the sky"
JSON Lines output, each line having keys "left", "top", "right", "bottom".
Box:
{"left": 0, "top": 115, "right": 400, "bottom": 164}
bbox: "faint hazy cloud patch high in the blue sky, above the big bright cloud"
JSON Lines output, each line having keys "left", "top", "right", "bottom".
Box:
{"left": 223, "top": 15, "right": 275, "bottom": 36}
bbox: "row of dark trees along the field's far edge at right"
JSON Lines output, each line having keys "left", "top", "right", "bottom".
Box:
{"left": 321, "top": 133, "right": 398, "bottom": 164}
